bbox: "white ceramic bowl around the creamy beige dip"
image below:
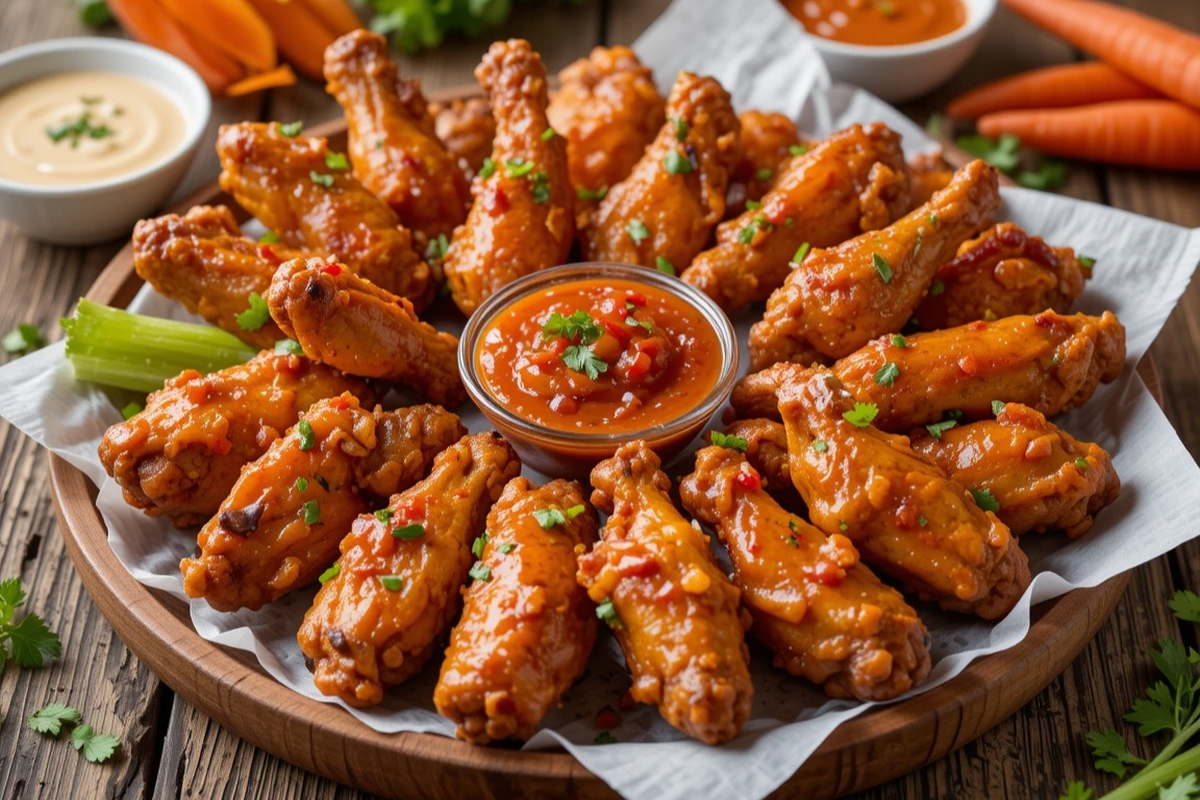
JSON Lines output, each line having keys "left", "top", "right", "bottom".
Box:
{"left": 0, "top": 37, "right": 211, "bottom": 245}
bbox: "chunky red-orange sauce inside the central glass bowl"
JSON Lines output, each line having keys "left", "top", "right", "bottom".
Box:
{"left": 475, "top": 279, "right": 721, "bottom": 433}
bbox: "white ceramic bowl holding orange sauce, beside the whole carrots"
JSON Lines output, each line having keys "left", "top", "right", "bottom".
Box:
{"left": 809, "top": 0, "right": 998, "bottom": 103}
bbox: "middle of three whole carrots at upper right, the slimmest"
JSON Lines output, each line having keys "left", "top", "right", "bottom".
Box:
{"left": 946, "top": 61, "right": 1163, "bottom": 120}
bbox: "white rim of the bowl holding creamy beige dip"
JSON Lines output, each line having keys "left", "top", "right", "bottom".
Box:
{"left": 0, "top": 36, "right": 212, "bottom": 198}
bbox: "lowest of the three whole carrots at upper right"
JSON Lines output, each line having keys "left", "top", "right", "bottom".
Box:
{"left": 977, "top": 100, "right": 1200, "bottom": 169}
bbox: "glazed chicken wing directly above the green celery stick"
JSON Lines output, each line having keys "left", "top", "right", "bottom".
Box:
{"left": 133, "top": 205, "right": 301, "bottom": 349}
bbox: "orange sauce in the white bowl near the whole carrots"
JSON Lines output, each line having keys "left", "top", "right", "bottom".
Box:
{"left": 781, "top": 0, "right": 969, "bottom": 46}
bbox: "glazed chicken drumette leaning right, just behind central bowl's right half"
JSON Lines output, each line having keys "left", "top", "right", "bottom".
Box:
{"left": 581, "top": 72, "right": 739, "bottom": 271}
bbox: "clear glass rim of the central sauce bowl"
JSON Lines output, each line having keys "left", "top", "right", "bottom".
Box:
{"left": 457, "top": 261, "right": 740, "bottom": 447}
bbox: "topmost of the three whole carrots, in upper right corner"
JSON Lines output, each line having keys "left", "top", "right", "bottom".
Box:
{"left": 1004, "top": 0, "right": 1200, "bottom": 108}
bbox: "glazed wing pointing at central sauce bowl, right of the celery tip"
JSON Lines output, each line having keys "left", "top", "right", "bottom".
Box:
{"left": 266, "top": 258, "right": 467, "bottom": 408}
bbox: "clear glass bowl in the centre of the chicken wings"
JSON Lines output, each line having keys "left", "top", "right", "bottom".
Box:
{"left": 458, "top": 263, "right": 738, "bottom": 477}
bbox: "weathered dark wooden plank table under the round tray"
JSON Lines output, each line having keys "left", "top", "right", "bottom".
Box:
{"left": 0, "top": 0, "right": 1200, "bottom": 800}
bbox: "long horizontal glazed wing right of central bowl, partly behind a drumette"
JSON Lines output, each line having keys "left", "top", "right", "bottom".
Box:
{"left": 731, "top": 311, "right": 1126, "bottom": 433}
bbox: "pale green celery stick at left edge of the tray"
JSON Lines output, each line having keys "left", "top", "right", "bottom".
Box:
{"left": 61, "top": 299, "right": 257, "bottom": 392}
